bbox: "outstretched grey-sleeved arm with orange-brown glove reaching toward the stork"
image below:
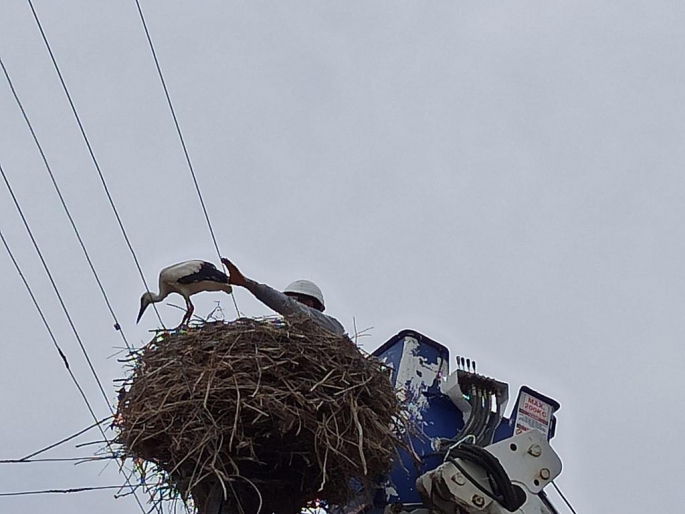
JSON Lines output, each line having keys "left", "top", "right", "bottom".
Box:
{"left": 221, "top": 258, "right": 345, "bottom": 335}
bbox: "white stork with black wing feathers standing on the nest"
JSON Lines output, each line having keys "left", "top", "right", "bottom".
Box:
{"left": 136, "top": 260, "right": 233, "bottom": 328}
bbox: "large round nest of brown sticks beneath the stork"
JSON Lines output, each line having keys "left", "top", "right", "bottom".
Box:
{"left": 117, "top": 319, "right": 407, "bottom": 514}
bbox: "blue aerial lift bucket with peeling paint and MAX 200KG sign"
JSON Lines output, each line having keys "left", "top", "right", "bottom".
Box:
{"left": 373, "top": 330, "right": 559, "bottom": 508}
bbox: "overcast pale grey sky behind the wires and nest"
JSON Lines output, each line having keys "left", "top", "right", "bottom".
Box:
{"left": 0, "top": 0, "right": 685, "bottom": 508}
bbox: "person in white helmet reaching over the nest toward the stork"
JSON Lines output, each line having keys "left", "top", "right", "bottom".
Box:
{"left": 221, "top": 257, "right": 345, "bottom": 335}
